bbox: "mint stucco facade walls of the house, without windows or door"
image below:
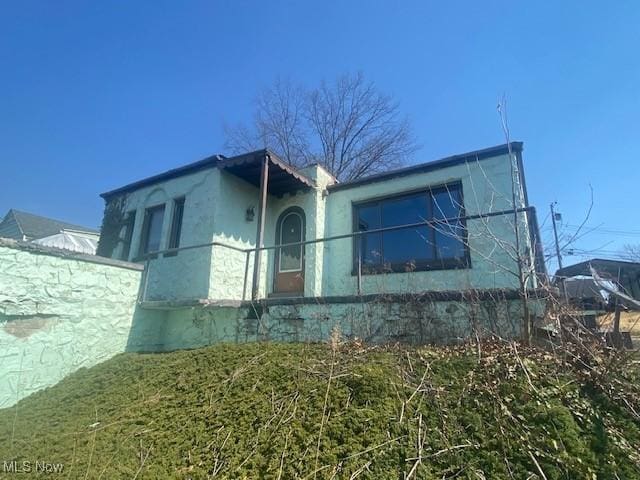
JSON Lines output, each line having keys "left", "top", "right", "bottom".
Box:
{"left": 97, "top": 150, "right": 536, "bottom": 300}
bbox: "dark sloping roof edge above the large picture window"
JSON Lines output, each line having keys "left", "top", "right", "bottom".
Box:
{"left": 327, "top": 142, "right": 523, "bottom": 192}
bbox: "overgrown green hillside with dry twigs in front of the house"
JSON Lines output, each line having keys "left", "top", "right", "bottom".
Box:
{"left": 0, "top": 344, "right": 640, "bottom": 480}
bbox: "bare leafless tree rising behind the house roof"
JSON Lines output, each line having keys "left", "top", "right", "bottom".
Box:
{"left": 225, "top": 73, "right": 417, "bottom": 180}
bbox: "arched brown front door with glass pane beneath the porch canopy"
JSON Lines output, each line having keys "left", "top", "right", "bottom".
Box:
{"left": 273, "top": 207, "right": 305, "bottom": 295}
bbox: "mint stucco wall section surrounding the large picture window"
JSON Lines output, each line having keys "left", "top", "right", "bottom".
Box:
{"left": 322, "top": 155, "right": 529, "bottom": 295}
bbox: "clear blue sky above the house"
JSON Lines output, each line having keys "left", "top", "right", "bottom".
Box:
{"left": 0, "top": 0, "right": 640, "bottom": 270}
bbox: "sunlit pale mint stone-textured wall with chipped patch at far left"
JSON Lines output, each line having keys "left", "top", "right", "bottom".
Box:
{"left": 0, "top": 239, "right": 144, "bottom": 408}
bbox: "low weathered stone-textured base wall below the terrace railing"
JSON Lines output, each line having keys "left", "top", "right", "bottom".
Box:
{"left": 139, "top": 292, "right": 544, "bottom": 351}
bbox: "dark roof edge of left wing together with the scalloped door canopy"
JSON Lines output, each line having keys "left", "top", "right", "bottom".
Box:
{"left": 100, "top": 149, "right": 315, "bottom": 200}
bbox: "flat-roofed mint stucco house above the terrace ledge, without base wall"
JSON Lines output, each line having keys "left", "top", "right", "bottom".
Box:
{"left": 98, "top": 142, "right": 545, "bottom": 302}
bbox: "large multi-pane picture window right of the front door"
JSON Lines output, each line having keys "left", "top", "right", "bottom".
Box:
{"left": 354, "top": 183, "right": 469, "bottom": 273}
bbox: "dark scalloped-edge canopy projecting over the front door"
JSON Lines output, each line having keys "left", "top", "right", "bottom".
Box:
{"left": 218, "top": 150, "right": 315, "bottom": 196}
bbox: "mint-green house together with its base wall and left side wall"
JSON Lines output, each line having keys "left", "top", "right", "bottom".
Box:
{"left": 0, "top": 143, "right": 546, "bottom": 408}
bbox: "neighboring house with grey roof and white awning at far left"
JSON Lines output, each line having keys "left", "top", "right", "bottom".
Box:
{"left": 0, "top": 209, "right": 100, "bottom": 255}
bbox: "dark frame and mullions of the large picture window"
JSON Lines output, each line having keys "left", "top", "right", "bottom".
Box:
{"left": 351, "top": 180, "right": 471, "bottom": 276}
